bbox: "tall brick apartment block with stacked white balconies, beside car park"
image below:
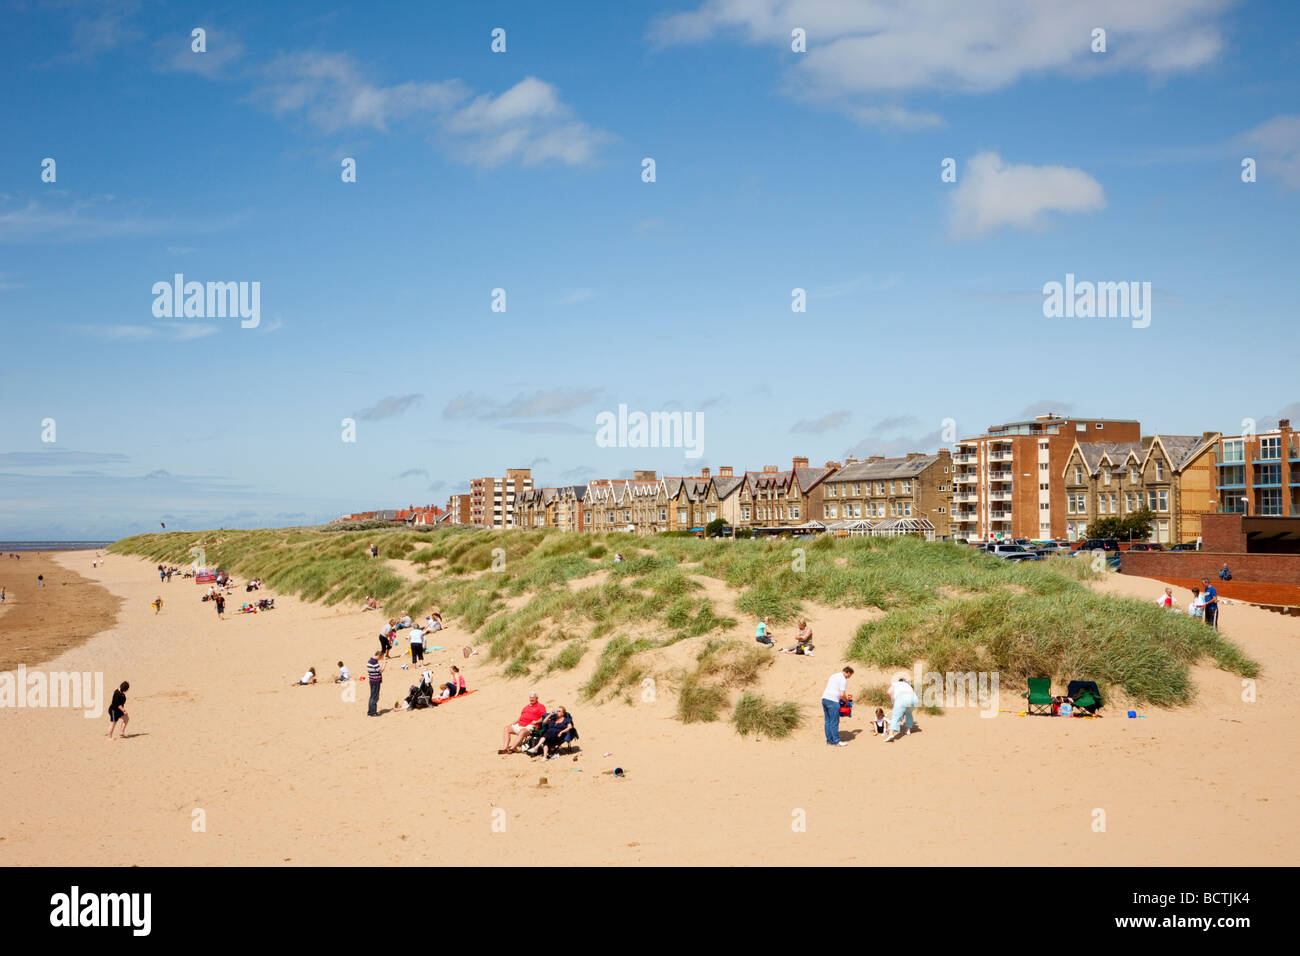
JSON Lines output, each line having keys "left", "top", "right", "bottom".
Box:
{"left": 949, "top": 415, "right": 1141, "bottom": 541}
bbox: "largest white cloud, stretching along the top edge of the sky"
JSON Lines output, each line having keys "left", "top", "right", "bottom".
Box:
{"left": 651, "top": 0, "right": 1236, "bottom": 129}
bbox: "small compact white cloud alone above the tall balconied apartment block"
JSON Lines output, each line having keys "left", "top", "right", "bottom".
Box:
{"left": 949, "top": 152, "right": 1106, "bottom": 239}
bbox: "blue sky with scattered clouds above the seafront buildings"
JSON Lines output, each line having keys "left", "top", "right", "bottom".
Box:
{"left": 0, "top": 0, "right": 1300, "bottom": 540}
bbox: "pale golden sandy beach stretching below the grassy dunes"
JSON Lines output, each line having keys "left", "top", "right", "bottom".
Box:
{"left": 0, "top": 553, "right": 1300, "bottom": 866}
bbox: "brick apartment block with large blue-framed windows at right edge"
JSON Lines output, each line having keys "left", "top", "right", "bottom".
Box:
{"left": 1212, "top": 419, "right": 1300, "bottom": 518}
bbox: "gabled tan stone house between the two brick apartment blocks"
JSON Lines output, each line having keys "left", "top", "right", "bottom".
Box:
{"left": 1062, "top": 432, "right": 1219, "bottom": 545}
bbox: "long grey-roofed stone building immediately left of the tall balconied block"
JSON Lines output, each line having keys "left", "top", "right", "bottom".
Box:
{"left": 816, "top": 449, "right": 954, "bottom": 541}
